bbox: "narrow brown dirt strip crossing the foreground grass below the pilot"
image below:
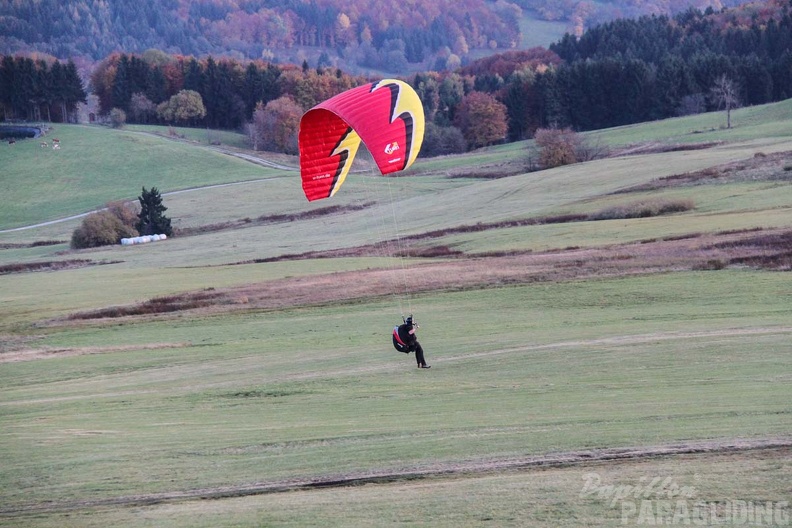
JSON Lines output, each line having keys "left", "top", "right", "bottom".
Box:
{"left": 0, "top": 437, "right": 792, "bottom": 519}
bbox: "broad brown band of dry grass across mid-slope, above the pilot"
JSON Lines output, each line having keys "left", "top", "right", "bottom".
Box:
{"left": 51, "top": 226, "right": 792, "bottom": 324}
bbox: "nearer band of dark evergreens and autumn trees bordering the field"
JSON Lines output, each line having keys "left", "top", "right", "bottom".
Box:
{"left": 0, "top": 1, "right": 792, "bottom": 155}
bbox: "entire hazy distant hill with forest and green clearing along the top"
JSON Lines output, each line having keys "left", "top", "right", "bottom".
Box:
{"left": 0, "top": 0, "right": 756, "bottom": 73}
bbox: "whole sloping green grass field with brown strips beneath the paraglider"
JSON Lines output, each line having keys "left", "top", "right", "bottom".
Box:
{"left": 0, "top": 101, "right": 792, "bottom": 527}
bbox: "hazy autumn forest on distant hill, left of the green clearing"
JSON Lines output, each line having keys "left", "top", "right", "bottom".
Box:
{"left": 0, "top": 0, "right": 522, "bottom": 72}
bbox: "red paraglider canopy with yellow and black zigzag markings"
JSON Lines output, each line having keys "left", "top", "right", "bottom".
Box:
{"left": 299, "top": 79, "right": 424, "bottom": 201}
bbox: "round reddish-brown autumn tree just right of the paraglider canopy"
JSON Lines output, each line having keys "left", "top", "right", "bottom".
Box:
{"left": 454, "top": 92, "right": 509, "bottom": 148}
